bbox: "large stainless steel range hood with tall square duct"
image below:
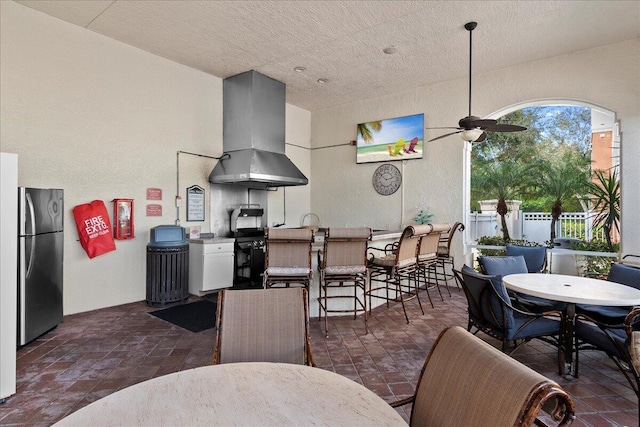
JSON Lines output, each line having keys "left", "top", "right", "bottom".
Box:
{"left": 209, "top": 70, "right": 309, "bottom": 189}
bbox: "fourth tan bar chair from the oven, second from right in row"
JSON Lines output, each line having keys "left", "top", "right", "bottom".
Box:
{"left": 416, "top": 224, "right": 451, "bottom": 308}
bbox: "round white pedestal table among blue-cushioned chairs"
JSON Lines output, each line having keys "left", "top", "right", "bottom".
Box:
{"left": 502, "top": 273, "right": 640, "bottom": 378}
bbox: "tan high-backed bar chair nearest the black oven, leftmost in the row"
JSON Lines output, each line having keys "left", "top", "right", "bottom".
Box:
{"left": 263, "top": 228, "right": 313, "bottom": 292}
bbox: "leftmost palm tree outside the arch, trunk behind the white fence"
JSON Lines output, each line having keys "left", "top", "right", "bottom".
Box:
{"left": 471, "top": 161, "right": 531, "bottom": 243}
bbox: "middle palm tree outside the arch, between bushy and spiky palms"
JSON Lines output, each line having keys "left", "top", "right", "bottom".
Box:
{"left": 536, "top": 150, "right": 591, "bottom": 242}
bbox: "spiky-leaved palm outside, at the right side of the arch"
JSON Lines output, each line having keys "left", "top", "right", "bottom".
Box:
{"left": 589, "top": 168, "right": 620, "bottom": 252}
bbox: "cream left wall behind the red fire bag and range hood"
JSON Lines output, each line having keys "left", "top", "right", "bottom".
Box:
{"left": 0, "top": 1, "right": 310, "bottom": 314}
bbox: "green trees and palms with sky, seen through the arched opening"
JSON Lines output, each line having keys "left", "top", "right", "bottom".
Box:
{"left": 471, "top": 106, "right": 591, "bottom": 244}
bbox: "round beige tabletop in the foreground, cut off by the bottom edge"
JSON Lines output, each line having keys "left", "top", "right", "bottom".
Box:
{"left": 54, "top": 362, "right": 407, "bottom": 427}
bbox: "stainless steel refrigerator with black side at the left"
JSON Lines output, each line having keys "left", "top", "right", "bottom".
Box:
{"left": 18, "top": 187, "right": 64, "bottom": 346}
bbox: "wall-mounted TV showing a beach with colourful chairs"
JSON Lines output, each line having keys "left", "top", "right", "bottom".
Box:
{"left": 356, "top": 114, "right": 424, "bottom": 163}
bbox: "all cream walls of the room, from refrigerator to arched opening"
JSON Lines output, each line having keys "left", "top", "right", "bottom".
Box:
{"left": 0, "top": 2, "right": 640, "bottom": 314}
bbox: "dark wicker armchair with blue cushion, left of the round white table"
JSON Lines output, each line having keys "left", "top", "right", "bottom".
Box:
{"left": 454, "top": 265, "right": 561, "bottom": 360}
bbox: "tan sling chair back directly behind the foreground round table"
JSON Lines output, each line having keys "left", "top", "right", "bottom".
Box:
{"left": 213, "top": 287, "right": 315, "bottom": 366}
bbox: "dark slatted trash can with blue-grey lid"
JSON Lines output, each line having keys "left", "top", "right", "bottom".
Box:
{"left": 147, "top": 225, "right": 189, "bottom": 306}
